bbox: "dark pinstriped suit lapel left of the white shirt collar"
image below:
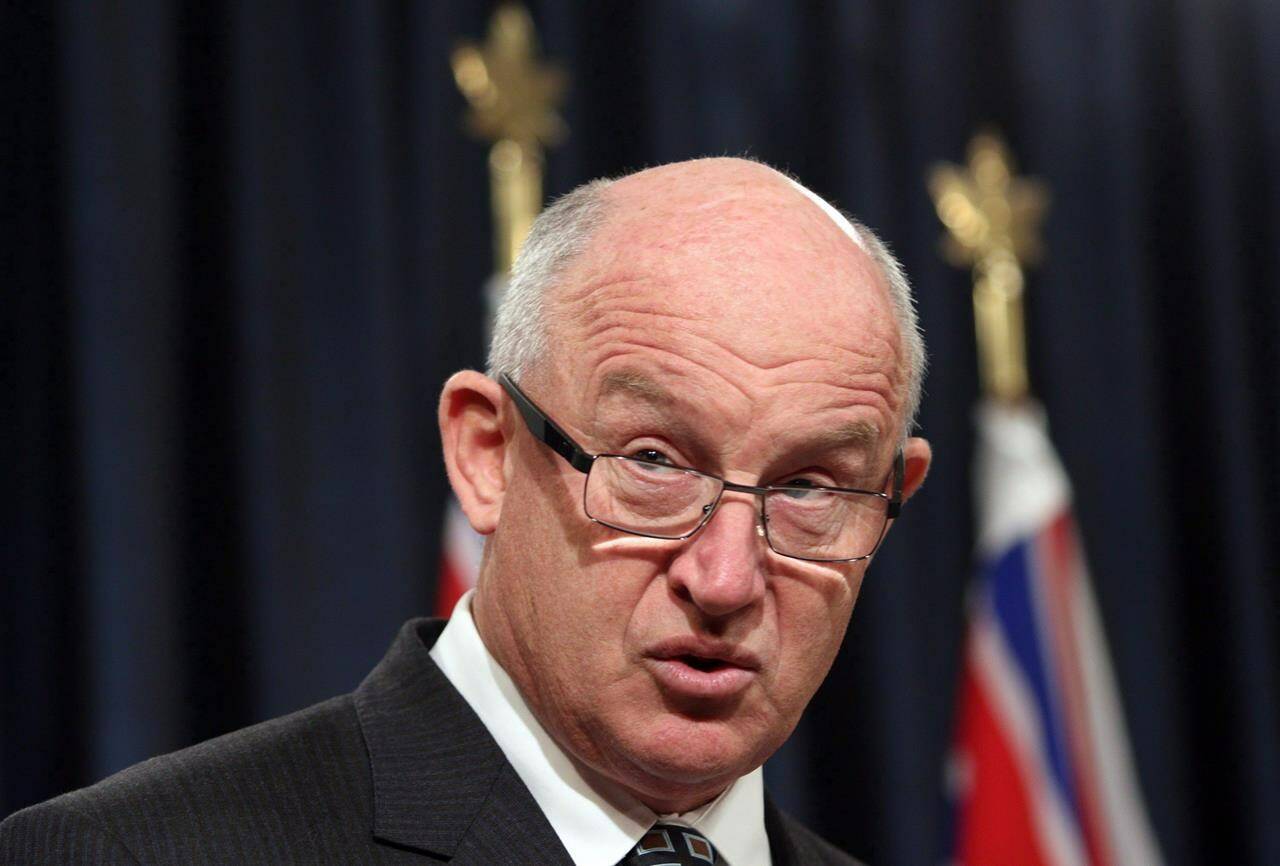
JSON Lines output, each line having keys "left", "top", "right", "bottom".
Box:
{"left": 355, "top": 619, "right": 572, "bottom": 866}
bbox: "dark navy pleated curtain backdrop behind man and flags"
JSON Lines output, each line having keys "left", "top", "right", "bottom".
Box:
{"left": 0, "top": 0, "right": 1280, "bottom": 866}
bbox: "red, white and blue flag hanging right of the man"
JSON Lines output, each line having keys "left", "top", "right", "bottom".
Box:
{"left": 947, "top": 403, "right": 1162, "bottom": 866}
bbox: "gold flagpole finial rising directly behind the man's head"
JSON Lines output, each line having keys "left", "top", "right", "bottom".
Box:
{"left": 452, "top": 3, "right": 566, "bottom": 276}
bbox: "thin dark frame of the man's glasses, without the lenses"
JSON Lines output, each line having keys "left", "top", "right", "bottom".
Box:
{"left": 498, "top": 372, "right": 906, "bottom": 563}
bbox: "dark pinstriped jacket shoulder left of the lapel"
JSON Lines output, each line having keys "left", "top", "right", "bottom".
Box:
{"left": 0, "top": 696, "right": 371, "bottom": 865}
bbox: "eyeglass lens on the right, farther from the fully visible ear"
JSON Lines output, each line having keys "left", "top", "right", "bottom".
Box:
{"left": 764, "top": 487, "right": 888, "bottom": 560}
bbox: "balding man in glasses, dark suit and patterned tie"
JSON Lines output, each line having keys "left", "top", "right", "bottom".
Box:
{"left": 0, "top": 160, "right": 929, "bottom": 866}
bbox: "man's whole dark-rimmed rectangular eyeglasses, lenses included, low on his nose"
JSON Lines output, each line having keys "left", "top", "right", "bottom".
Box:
{"left": 498, "top": 374, "right": 904, "bottom": 563}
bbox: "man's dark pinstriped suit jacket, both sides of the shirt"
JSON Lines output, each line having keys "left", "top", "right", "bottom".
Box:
{"left": 0, "top": 619, "right": 854, "bottom": 866}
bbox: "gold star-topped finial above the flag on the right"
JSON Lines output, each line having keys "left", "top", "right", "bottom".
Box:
{"left": 929, "top": 132, "right": 1050, "bottom": 402}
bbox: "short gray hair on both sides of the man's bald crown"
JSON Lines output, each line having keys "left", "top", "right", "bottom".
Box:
{"left": 489, "top": 167, "right": 927, "bottom": 437}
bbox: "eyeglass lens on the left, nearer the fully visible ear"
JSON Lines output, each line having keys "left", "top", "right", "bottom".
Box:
{"left": 585, "top": 457, "right": 721, "bottom": 539}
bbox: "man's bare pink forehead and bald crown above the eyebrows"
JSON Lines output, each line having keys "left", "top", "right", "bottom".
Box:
{"left": 552, "top": 166, "right": 902, "bottom": 442}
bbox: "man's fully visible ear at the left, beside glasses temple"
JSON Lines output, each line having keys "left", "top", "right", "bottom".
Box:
{"left": 439, "top": 370, "right": 511, "bottom": 535}
